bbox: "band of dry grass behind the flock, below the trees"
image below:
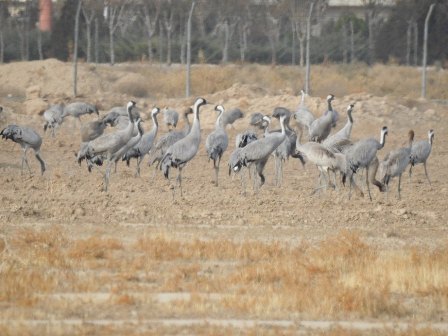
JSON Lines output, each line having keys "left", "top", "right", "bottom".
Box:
{"left": 101, "top": 64, "right": 448, "bottom": 99}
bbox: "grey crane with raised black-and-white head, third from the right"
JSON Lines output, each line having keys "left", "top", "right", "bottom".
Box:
{"left": 346, "top": 126, "right": 388, "bottom": 200}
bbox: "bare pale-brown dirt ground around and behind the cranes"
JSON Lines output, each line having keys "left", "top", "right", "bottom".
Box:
{"left": 0, "top": 62, "right": 448, "bottom": 334}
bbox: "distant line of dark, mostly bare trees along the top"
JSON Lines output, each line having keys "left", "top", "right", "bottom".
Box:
{"left": 0, "top": 0, "right": 448, "bottom": 66}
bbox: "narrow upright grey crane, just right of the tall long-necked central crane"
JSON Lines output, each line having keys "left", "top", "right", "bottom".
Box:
{"left": 205, "top": 105, "right": 229, "bottom": 186}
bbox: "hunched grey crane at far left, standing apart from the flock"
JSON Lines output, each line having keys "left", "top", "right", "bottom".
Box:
{"left": 0, "top": 125, "right": 46, "bottom": 175}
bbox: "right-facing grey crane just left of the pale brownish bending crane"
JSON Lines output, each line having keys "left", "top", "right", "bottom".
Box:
{"left": 232, "top": 115, "right": 286, "bottom": 187}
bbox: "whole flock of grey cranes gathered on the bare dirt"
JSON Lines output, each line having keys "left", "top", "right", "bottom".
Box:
{"left": 0, "top": 91, "right": 434, "bottom": 200}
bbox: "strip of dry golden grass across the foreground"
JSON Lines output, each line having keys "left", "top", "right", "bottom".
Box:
{"left": 0, "top": 226, "right": 448, "bottom": 335}
